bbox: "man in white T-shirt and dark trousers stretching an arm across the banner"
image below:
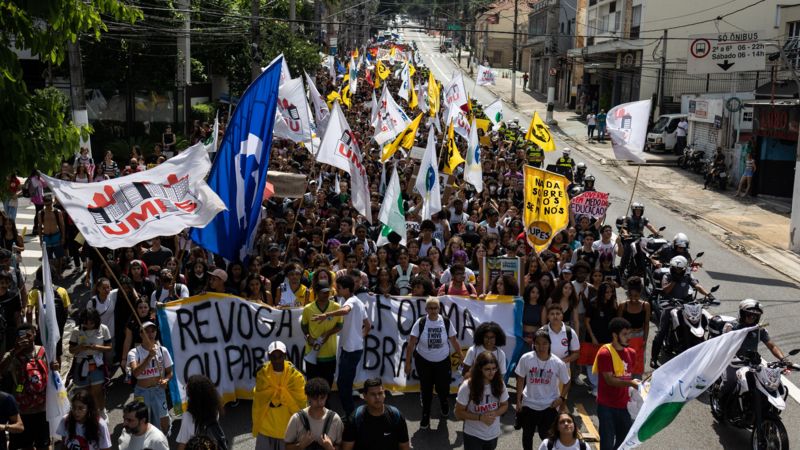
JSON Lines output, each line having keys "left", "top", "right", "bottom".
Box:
{"left": 312, "top": 275, "right": 372, "bottom": 416}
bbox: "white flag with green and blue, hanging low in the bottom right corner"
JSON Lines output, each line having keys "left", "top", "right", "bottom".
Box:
{"left": 619, "top": 327, "right": 755, "bottom": 450}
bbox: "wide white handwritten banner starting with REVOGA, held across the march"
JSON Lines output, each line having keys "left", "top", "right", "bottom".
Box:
{"left": 158, "top": 294, "right": 522, "bottom": 407}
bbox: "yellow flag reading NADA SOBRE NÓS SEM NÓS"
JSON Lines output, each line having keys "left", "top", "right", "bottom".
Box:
{"left": 523, "top": 165, "right": 569, "bottom": 253}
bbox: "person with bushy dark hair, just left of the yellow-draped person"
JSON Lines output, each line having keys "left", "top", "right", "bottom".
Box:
{"left": 175, "top": 375, "right": 225, "bottom": 450}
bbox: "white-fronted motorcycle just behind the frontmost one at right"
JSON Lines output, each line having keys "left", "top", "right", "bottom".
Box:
{"left": 658, "top": 285, "right": 720, "bottom": 360}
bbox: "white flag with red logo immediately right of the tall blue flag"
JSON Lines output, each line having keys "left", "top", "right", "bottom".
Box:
{"left": 273, "top": 78, "right": 314, "bottom": 143}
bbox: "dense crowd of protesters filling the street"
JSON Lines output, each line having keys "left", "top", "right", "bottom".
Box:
{"left": 0, "top": 45, "right": 649, "bottom": 450}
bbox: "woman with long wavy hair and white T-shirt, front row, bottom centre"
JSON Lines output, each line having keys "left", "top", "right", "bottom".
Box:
{"left": 456, "top": 351, "right": 508, "bottom": 450}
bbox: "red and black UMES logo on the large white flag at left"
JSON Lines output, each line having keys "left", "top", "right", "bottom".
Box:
{"left": 86, "top": 174, "right": 199, "bottom": 237}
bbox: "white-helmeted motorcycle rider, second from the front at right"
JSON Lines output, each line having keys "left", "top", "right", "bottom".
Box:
{"left": 650, "top": 256, "right": 715, "bottom": 369}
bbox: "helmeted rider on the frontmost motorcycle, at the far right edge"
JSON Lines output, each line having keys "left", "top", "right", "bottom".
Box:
{"left": 720, "top": 298, "right": 789, "bottom": 411}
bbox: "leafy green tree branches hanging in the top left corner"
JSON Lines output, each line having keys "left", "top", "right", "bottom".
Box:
{"left": 0, "top": 0, "right": 142, "bottom": 179}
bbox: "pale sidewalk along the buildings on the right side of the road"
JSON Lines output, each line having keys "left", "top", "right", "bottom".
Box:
{"left": 453, "top": 54, "right": 800, "bottom": 283}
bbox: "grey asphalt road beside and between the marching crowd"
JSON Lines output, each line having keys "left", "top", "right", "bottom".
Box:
{"left": 9, "top": 25, "right": 800, "bottom": 450}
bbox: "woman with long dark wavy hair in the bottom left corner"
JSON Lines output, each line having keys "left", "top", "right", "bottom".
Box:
{"left": 56, "top": 389, "right": 111, "bottom": 450}
